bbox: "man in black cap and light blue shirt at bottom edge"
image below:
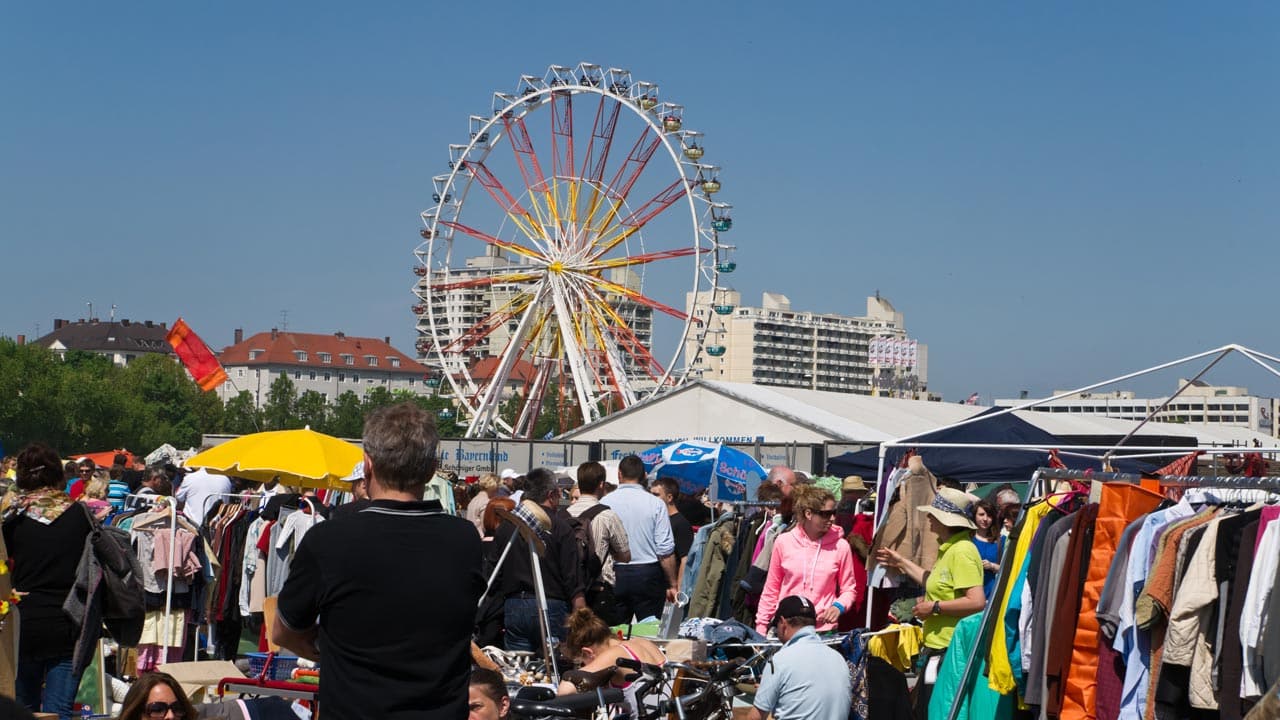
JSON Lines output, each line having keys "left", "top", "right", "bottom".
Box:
{"left": 748, "top": 594, "right": 852, "bottom": 720}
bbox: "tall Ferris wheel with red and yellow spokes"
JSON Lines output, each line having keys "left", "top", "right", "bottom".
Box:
{"left": 412, "top": 63, "right": 736, "bottom": 437}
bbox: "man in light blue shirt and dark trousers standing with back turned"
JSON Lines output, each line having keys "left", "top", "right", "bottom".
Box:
{"left": 600, "top": 455, "right": 676, "bottom": 620}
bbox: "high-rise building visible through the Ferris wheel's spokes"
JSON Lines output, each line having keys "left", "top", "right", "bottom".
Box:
{"left": 413, "top": 247, "right": 653, "bottom": 373}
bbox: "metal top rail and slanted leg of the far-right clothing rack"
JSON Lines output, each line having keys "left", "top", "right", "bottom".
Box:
{"left": 946, "top": 468, "right": 1280, "bottom": 720}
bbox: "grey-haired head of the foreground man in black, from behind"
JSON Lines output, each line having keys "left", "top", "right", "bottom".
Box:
{"left": 364, "top": 402, "right": 440, "bottom": 491}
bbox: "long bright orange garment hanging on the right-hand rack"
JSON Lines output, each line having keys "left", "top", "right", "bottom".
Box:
{"left": 1059, "top": 483, "right": 1165, "bottom": 720}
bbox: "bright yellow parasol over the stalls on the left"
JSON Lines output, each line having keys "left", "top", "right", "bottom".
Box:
{"left": 184, "top": 428, "right": 364, "bottom": 491}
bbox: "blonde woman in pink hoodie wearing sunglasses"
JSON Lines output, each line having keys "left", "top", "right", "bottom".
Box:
{"left": 755, "top": 486, "right": 860, "bottom": 634}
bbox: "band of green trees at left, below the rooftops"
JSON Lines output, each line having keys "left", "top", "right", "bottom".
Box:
{"left": 0, "top": 337, "right": 488, "bottom": 456}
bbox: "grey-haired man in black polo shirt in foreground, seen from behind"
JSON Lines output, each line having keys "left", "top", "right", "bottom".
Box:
{"left": 271, "top": 402, "right": 484, "bottom": 720}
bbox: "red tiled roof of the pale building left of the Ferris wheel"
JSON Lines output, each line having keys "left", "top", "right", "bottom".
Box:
{"left": 218, "top": 331, "right": 430, "bottom": 375}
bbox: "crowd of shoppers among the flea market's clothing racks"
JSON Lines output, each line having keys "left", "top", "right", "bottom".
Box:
{"left": 0, "top": 405, "right": 1018, "bottom": 719}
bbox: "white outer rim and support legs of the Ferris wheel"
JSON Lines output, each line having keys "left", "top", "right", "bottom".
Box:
{"left": 415, "top": 63, "right": 733, "bottom": 437}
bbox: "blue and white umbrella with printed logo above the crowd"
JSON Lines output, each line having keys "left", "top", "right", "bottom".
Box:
{"left": 640, "top": 439, "right": 767, "bottom": 501}
